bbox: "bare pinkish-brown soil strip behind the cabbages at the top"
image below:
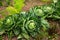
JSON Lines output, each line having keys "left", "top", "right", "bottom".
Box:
{"left": 22, "top": 0, "right": 50, "bottom": 11}
